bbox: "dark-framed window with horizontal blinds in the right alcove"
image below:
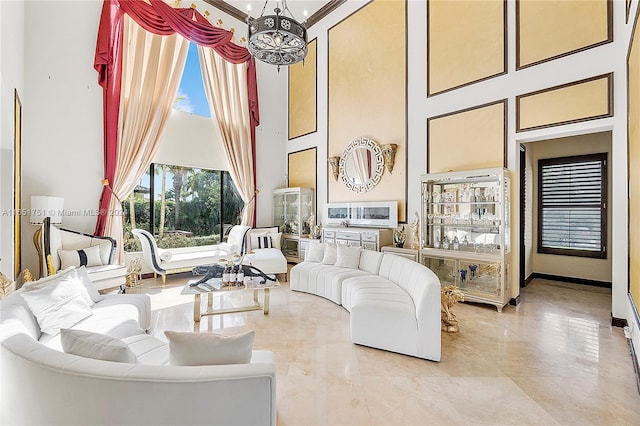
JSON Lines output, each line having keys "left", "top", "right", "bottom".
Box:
{"left": 538, "top": 153, "right": 607, "bottom": 259}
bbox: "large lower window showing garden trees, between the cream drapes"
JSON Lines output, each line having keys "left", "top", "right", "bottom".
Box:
{"left": 123, "top": 164, "right": 244, "bottom": 251}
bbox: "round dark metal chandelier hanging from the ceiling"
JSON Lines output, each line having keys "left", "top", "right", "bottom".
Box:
{"left": 247, "top": 0, "right": 307, "bottom": 71}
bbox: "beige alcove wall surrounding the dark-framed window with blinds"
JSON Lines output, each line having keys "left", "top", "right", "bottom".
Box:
{"left": 527, "top": 132, "right": 613, "bottom": 282}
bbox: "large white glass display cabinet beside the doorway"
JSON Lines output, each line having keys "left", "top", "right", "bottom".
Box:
{"left": 420, "top": 168, "right": 511, "bottom": 312}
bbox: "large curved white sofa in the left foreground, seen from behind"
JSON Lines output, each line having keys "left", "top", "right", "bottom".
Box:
{"left": 0, "top": 272, "right": 276, "bottom": 425}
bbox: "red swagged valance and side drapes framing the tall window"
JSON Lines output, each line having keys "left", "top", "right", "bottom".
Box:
{"left": 93, "top": 0, "right": 260, "bottom": 235}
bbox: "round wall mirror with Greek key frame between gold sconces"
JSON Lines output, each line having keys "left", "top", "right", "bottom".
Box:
{"left": 339, "top": 138, "right": 384, "bottom": 193}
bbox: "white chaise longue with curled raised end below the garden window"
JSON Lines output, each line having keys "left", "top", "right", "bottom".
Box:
{"left": 131, "top": 229, "right": 236, "bottom": 284}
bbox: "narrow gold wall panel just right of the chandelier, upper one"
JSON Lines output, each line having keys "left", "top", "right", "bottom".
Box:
{"left": 289, "top": 39, "right": 318, "bottom": 139}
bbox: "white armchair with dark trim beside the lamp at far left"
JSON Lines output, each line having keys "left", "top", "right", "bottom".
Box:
{"left": 40, "top": 217, "right": 127, "bottom": 290}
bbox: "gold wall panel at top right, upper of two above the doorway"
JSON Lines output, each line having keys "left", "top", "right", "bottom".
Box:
{"left": 516, "top": 0, "right": 613, "bottom": 68}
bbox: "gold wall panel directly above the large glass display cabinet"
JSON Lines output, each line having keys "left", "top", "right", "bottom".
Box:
{"left": 427, "top": 100, "right": 507, "bottom": 173}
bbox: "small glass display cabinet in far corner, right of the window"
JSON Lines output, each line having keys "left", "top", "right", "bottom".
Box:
{"left": 273, "top": 188, "right": 315, "bottom": 262}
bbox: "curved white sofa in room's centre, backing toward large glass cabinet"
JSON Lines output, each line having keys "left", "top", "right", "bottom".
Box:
{"left": 289, "top": 243, "right": 441, "bottom": 361}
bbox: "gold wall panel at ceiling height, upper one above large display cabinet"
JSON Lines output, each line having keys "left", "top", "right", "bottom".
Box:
{"left": 427, "top": 0, "right": 506, "bottom": 95}
